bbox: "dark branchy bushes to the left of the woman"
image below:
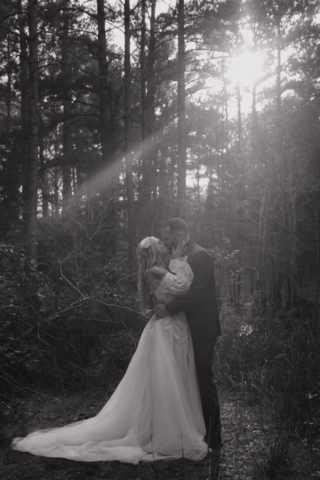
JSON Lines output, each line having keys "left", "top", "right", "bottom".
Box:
{"left": 0, "top": 231, "right": 145, "bottom": 412}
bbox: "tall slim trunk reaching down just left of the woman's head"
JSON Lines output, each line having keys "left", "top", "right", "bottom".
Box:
{"left": 124, "top": 0, "right": 136, "bottom": 273}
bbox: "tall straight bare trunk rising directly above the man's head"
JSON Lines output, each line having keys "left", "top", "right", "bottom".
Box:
{"left": 178, "top": 0, "right": 187, "bottom": 216}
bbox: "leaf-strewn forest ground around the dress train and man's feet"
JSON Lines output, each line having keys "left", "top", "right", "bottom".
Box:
{"left": 0, "top": 388, "right": 320, "bottom": 480}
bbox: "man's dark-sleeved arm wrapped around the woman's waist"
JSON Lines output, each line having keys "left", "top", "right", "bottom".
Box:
{"left": 166, "top": 250, "right": 214, "bottom": 315}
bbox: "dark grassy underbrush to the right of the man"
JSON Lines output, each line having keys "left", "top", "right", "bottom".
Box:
{"left": 216, "top": 305, "right": 320, "bottom": 478}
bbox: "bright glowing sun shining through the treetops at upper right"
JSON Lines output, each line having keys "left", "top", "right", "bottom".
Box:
{"left": 226, "top": 52, "right": 264, "bottom": 87}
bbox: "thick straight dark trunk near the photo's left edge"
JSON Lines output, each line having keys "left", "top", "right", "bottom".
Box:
{"left": 26, "top": 0, "right": 38, "bottom": 261}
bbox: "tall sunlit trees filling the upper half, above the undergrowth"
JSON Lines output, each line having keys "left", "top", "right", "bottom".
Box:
{"left": 0, "top": 0, "right": 320, "bottom": 307}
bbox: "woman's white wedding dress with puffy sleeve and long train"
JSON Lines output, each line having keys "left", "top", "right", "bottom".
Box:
{"left": 12, "top": 259, "right": 207, "bottom": 464}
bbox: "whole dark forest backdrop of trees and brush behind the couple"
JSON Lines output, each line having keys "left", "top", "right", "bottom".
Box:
{"left": 0, "top": 0, "right": 320, "bottom": 476}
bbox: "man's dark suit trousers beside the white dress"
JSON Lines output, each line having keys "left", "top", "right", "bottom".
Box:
{"left": 193, "top": 338, "right": 222, "bottom": 447}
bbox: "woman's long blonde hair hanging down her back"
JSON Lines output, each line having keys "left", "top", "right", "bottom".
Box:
{"left": 137, "top": 237, "right": 162, "bottom": 313}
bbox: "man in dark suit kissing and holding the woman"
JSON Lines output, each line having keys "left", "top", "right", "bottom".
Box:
{"left": 154, "top": 218, "right": 222, "bottom": 449}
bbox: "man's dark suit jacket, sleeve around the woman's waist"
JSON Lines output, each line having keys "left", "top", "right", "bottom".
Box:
{"left": 166, "top": 240, "right": 221, "bottom": 339}
